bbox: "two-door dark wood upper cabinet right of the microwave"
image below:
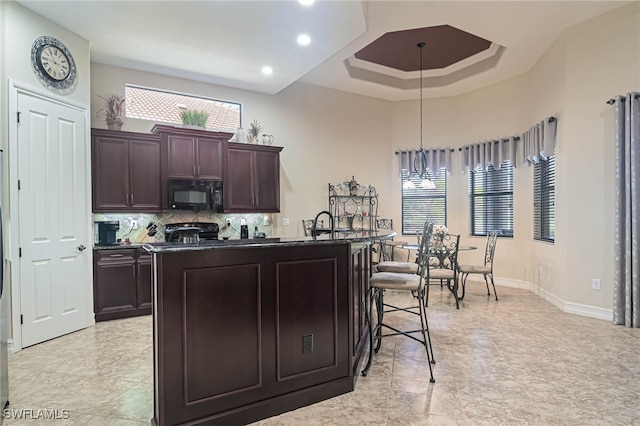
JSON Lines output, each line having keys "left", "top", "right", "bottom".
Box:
{"left": 224, "top": 143, "right": 282, "bottom": 213}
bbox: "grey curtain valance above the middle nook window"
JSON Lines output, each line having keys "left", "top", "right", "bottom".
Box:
{"left": 460, "top": 136, "right": 520, "bottom": 173}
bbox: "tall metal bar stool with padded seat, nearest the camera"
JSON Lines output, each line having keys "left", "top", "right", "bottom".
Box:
{"left": 362, "top": 222, "right": 436, "bottom": 383}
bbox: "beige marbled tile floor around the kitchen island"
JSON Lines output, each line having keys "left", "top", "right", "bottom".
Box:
{"left": 4, "top": 283, "right": 640, "bottom": 426}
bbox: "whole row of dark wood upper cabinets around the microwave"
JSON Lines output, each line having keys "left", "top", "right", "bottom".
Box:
{"left": 92, "top": 125, "right": 282, "bottom": 213}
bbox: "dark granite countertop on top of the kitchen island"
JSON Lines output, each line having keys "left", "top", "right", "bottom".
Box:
{"left": 143, "top": 232, "right": 397, "bottom": 253}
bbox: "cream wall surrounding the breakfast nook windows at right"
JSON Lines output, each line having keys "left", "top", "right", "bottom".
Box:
{"left": 392, "top": 3, "right": 640, "bottom": 312}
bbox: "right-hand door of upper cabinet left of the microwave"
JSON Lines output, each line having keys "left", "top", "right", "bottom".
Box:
{"left": 129, "top": 140, "right": 162, "bottom": 212}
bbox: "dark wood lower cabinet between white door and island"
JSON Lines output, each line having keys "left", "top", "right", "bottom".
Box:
{"left": 93, "top": 248, "right": 151, "bottom": 321}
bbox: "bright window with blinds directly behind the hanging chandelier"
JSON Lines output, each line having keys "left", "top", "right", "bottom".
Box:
{"left": 402, "top": 169, "right": 447, "bottom": 235}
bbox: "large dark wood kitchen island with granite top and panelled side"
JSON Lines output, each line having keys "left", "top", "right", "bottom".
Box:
{"left": 145, "top": 232, "right": 395, "bottom": 426}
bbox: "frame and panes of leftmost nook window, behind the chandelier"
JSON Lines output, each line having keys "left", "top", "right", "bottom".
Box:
{"left": 400, "top": 167, "right": 448, "bottom": 235}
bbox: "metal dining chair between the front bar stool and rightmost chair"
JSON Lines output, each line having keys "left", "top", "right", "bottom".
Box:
{"left": 425, "top": 233, "right": 460, "bottom": 309}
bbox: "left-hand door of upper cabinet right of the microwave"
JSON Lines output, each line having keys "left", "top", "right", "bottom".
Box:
{"left": 224, "top": 148, "right": 255, "bottom": 210}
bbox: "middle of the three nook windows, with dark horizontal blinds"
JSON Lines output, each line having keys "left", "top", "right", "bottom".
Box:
{"left": 469, "top": 161, "right": 513, "bottom": 237}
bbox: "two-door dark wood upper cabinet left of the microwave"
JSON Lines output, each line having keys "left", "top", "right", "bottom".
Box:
{"left": 91, "top": 129, "right": 162, "bottom": 212}
